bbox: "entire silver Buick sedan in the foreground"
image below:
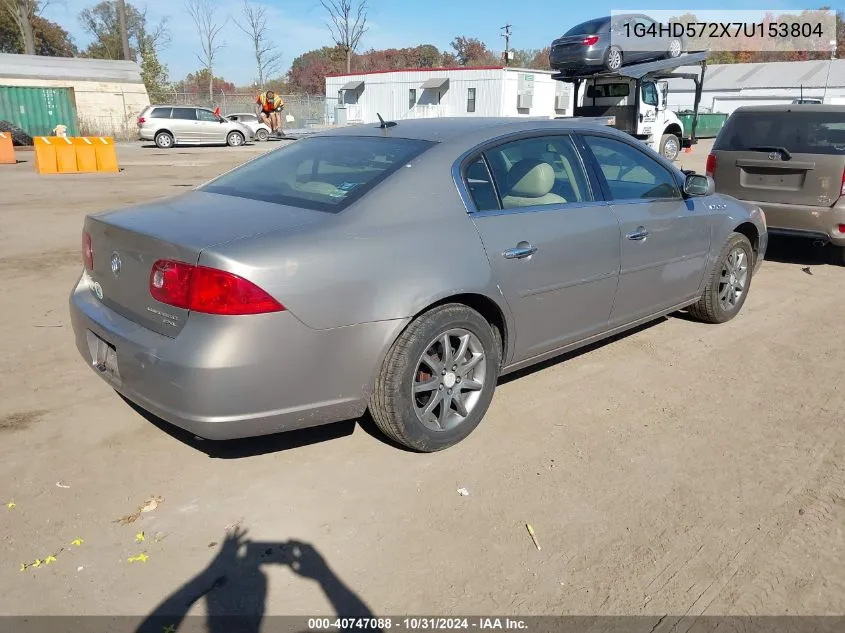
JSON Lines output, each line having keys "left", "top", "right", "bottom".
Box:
{"left": 70, "top": 118, "right": 767, "bottom": 451}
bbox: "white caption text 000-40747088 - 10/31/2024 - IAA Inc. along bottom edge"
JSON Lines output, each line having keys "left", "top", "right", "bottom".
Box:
{"left": 308, "top": 616, "right": 528, "bottom": 631}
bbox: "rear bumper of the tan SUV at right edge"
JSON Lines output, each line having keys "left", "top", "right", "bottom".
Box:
{"left": 745, "top": 199, "right": 845, "bottom": 246}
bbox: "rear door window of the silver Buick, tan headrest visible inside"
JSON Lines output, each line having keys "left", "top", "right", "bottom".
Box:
{"left": 466, "top": 135, "right": 594, "bottom": 210}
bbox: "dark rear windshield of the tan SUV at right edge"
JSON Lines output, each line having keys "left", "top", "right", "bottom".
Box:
{"left": 713, "top": 110, "right": 845, "bottom": 154}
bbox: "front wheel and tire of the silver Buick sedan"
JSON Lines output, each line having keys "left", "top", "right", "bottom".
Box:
{"left": 689, "top": 233, "right": 754, "bottom": 323}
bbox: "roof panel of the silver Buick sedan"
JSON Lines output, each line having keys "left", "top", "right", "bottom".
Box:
{"left": 313, "top": 117, "right": 630, "bottom": 145}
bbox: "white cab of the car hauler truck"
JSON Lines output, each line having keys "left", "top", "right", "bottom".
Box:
{"left": 575, "top": 76, "right": 685, "bottom": 160}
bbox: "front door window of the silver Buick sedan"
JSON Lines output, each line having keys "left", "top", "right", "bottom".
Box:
{"left": 584, "top": 136, "right": 681, "bottom": 200}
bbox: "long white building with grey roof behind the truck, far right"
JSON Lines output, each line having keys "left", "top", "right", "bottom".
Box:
{"left": 669, "top": 59, "right": 845, "bottom": 114}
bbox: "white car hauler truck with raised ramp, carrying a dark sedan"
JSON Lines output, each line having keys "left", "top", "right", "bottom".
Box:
{"left": 553, "top": 51, "right": 708, "bottom": 160}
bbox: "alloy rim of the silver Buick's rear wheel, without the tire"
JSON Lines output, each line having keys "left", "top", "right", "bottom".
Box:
{"left": 411, "top": 328, "right": 487, "bottom": 432}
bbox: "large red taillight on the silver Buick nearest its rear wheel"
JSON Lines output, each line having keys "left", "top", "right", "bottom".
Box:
{"left": 150, "top": 259, "right": 285, "bottom": 315}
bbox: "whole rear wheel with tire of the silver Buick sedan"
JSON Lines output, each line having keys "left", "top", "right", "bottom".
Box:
{"left": 369, "top": 303, "right": 502, "bottom": 453}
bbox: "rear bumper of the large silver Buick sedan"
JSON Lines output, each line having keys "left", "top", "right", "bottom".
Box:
{"left": 70, "top": 275, "right": 406, "bottom": 440}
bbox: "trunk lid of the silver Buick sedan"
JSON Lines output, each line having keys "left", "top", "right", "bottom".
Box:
{"left": 85, "top": 191, "right": 332, "bottom": 337}
